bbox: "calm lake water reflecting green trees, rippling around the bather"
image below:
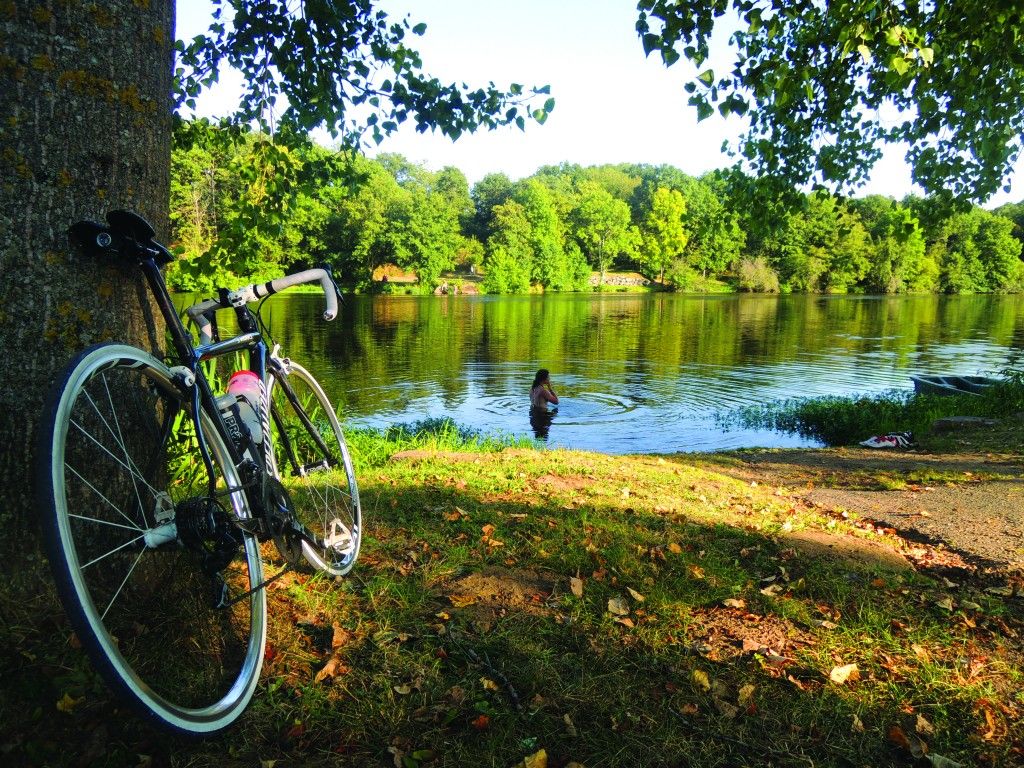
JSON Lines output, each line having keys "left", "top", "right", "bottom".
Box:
{"left": 179, "top": 294, "right": 1024, "bottom": 453}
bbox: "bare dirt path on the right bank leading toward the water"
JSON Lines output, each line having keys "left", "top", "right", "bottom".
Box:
{"left": 707, "top": 449, "right": 1024, "bottom": 570}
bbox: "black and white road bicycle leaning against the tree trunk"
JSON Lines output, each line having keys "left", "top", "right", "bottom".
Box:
{"left": 37, "top": 211, "right": 361, "bottom": 734}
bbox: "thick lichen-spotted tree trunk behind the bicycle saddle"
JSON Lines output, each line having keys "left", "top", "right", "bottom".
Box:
{"left": 0, "top": 0, "right": 174, "bottom": 550}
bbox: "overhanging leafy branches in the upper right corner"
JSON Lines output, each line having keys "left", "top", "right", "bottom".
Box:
{"left": 637, "top": 0, "right": 1024, "bottom": 200}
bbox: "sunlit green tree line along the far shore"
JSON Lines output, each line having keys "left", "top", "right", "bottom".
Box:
{"left": 168, "top": 121, "right": 1024, "bottom": 293}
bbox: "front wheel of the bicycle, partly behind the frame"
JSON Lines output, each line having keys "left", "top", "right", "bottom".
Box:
{"left": 267, "top": 360, "right": 362, "bottom": 575}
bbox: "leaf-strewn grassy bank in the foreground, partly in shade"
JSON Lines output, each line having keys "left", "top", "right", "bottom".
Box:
{"left": 8, "top": 436, "right": 1024, "bottom": 768}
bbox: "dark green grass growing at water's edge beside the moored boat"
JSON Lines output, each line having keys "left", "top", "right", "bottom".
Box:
{"left": 720, "top": 371, "right": 1024, "bottom": 445}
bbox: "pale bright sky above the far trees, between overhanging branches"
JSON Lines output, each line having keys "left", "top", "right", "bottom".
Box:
{"left": 177, "top": 0, "right": 1024, "bottom": 207}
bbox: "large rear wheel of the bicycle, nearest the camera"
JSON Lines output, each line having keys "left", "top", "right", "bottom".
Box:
{"left": 38, "top": 344, "right": 266, "bottom": 734}
